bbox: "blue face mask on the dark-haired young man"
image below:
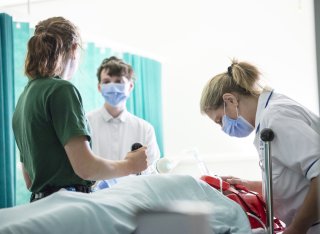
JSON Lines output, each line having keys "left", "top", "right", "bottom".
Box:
{"left": 101, "top": 83, "right": 129, "bottom": 107}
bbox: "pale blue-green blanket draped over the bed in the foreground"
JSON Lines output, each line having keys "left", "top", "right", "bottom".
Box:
{"left": 0, "top": 175, "right": 251, "bottom": 234}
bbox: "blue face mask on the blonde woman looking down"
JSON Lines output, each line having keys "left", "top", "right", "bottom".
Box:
{"left": 222, "top": 102, "right": 254, "bottom": 137}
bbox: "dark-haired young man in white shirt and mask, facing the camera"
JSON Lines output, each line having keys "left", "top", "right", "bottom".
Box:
{"left": 87, "top": 56, "right": 160, "bottom": 185}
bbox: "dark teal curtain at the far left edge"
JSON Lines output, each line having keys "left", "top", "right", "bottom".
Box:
{"left": 0, "top": 13, "right": 16, "bottom": 208}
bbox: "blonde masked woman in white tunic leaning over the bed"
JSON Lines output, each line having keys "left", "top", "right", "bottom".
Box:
{"left": 200, "top": 59, "right": 320, "bottom": 234}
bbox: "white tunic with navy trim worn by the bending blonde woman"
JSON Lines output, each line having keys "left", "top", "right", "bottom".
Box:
{"left": 254, "top": 91, "right": 320, "bottom": 233}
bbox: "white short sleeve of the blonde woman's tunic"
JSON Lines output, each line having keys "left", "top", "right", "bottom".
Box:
{"left": 263, "top": 106, "right": 320, "bottom": 179}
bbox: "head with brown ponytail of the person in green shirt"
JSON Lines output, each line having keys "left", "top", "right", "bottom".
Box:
{"left": 25, "top": 17, "right": 80, "bottom": 78}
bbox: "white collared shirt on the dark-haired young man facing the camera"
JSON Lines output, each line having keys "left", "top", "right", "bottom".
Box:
{"left": 87, "top": 107, "right": 160, "bottom": 174}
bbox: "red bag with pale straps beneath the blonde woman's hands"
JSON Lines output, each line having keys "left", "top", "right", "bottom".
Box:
{"left": 200, "top": 176, "right": 284, "bottom": 233}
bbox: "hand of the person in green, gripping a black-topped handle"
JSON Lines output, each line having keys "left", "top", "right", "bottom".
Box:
{"left": 124, "top": 146, "right": 148, "bottom": 174}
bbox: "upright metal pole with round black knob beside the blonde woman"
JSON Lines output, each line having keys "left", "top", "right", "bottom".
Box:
{"left": 260, "top": 128, "right": 274, "bottom": 234}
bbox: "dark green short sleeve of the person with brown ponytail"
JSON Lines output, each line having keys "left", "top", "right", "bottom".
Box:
{"left": 49, "top": 83, "right": 90, "bottom": 146}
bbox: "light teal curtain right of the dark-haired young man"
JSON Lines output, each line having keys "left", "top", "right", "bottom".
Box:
{"left": 123, "top": 53, "right": 164, "bottom": 156}
